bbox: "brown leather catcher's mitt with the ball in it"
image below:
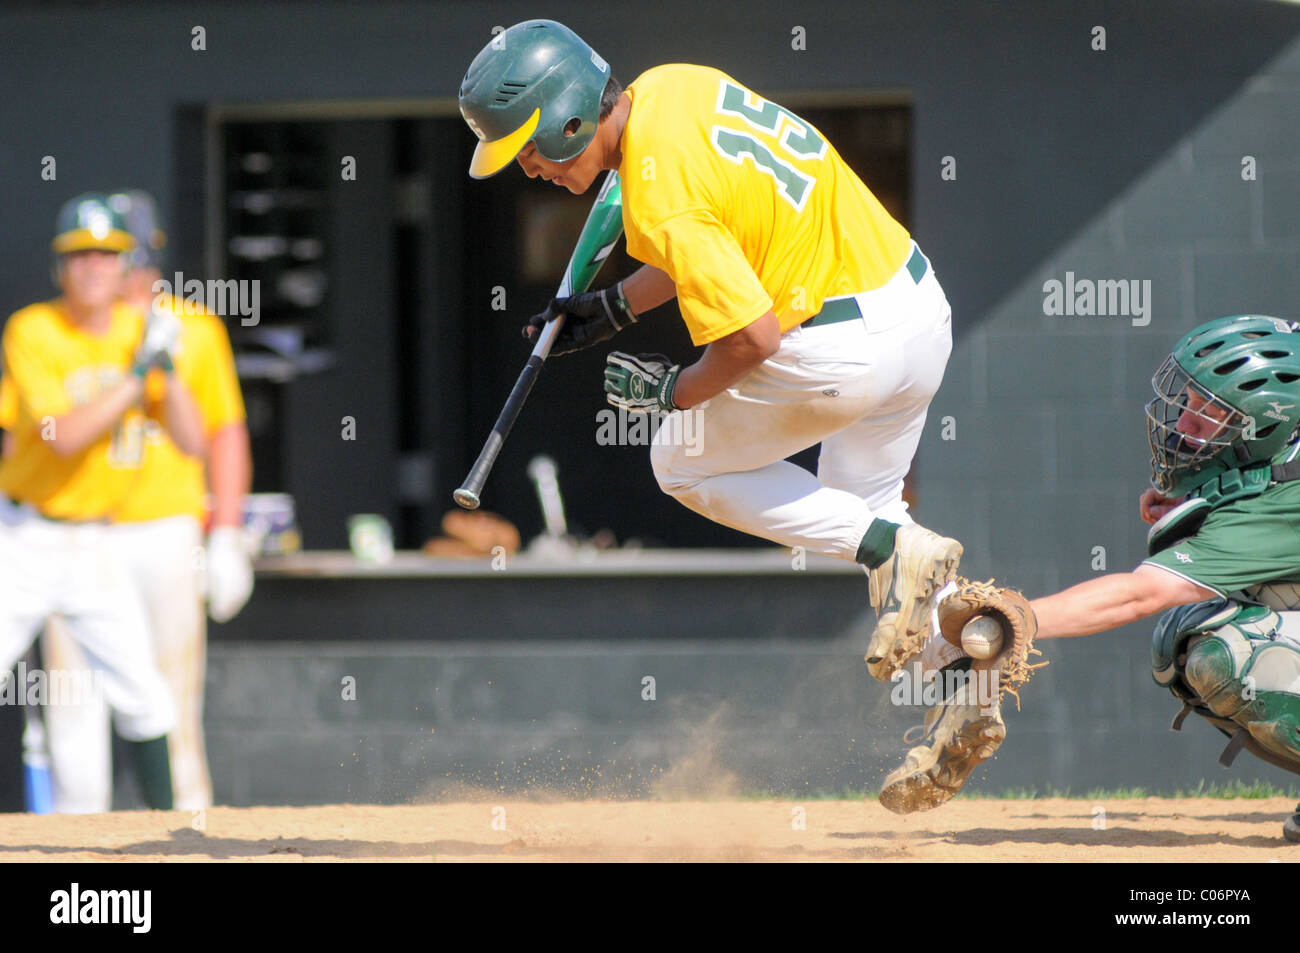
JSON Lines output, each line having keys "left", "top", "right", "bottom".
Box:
{"left": 939, "top": 576, "right": 1047, "bottom": 710}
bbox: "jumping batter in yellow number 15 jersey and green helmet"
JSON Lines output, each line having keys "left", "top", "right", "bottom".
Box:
{"left": 460, "top": 20, "right": 987, "bottom": 806}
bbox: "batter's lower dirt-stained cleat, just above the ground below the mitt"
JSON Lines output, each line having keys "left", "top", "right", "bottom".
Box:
{"left": 880, "top": 683, "right": 1006, "bottom": 814}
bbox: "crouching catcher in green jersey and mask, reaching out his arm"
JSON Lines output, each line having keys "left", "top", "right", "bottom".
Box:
{"left": 881, "top": 315, "right": 1300, "bottom": 842}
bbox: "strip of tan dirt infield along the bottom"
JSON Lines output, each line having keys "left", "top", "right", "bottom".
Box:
{"left": 0, "top": 798, "right": 1300, "bottom": 863}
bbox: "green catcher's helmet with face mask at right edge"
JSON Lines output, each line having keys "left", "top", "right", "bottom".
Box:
{"left": 1147, "top": 315, "right": 1300, "bottom": 498}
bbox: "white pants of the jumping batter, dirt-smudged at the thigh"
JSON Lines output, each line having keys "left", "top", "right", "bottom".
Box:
{"left": 650, "top": 245, "right": 952, "bottom": 559}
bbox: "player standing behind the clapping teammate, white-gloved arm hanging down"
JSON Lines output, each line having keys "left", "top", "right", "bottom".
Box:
{"left": 24, "top": 190, "right": 252, "bottom": 814}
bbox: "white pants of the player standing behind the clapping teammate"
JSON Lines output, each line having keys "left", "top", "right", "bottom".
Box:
{"left": 42, "top": 516, "right": 212, "bottom": 814}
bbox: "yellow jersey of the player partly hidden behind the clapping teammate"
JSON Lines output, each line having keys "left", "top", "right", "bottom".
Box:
{"left": 109, "top": 299, "right": 244, "bottom": 523}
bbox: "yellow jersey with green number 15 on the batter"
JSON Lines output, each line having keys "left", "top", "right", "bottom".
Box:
{"left": 619, "top": 64, "right": 911, "bottom": 345}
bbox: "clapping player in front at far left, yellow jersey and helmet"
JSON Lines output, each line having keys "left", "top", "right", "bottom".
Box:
{"left": 0, "top": 192, "right": 203, "bottom": 809}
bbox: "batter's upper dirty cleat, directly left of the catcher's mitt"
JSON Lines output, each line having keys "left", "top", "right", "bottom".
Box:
{"left": 866, "top": 523, "right": 962, "bottom": 681}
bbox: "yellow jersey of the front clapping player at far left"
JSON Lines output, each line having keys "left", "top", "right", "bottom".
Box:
{"left": 0, "top": 299, "right": 147, "bottom": 520}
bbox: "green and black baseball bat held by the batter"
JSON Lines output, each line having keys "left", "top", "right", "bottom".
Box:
{"left": 451, "top": 172, "right": 623, "bottom": 510}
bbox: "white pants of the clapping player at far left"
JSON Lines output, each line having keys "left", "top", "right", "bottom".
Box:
{"left": 0, "top": 498, "right": 176, "bottom": 790}
